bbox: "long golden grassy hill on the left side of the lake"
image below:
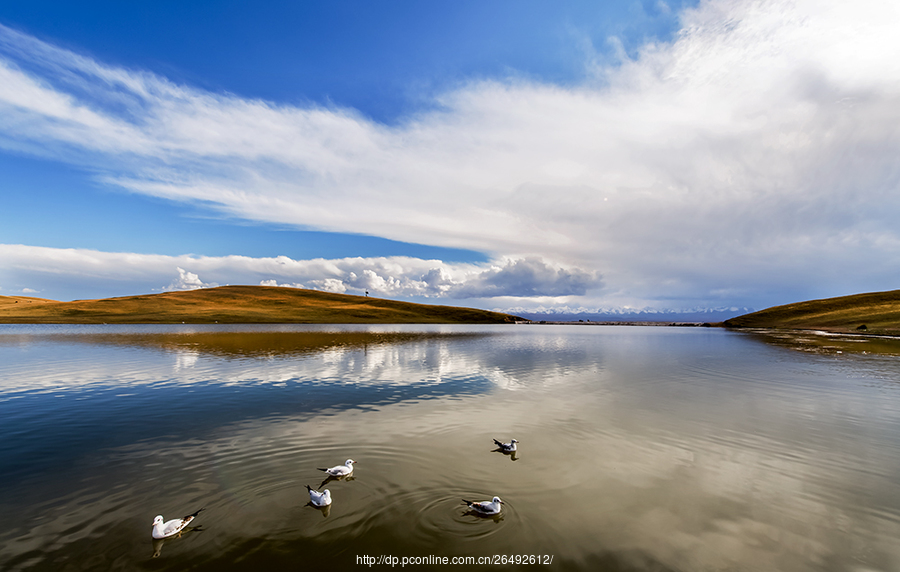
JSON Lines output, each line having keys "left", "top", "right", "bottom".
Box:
{"left": 0, "top": 286, "right": 527, "bottom": 324}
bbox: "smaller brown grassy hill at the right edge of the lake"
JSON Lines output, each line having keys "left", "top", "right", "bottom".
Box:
{"left": 724, "top": 290, "right": 900, "bottom": 335}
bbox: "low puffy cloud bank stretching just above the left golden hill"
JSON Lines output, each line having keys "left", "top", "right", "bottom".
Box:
{"left": 0, "top": 244, "right": 600, "bottom": 300}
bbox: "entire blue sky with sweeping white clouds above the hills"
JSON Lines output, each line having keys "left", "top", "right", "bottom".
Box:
{"left": 0, "top": 0, "right": 900, "bottom": 314}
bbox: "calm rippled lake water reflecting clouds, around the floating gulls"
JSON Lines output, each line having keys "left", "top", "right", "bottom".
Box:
{"left": 0, "top": 326, "right": 900, "bottom": 572}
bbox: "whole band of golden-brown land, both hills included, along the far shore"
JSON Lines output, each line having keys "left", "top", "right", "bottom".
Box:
{"left": 7, "top": 286, "right": 900, "bottom": 336}
